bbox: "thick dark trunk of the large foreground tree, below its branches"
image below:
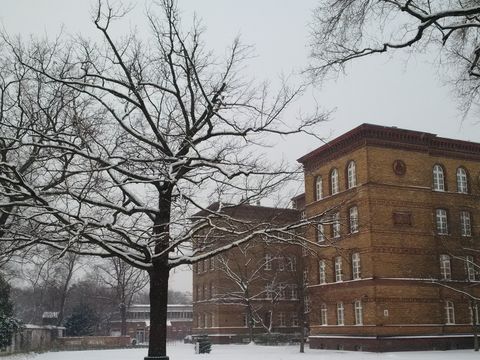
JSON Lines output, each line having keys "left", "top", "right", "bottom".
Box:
{"left": 145, "top": 260, "right": 169, "bottom": 360}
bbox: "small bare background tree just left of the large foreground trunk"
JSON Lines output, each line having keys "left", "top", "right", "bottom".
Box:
{"left": 96, "top": 258, "right": 148, "bottom": 335}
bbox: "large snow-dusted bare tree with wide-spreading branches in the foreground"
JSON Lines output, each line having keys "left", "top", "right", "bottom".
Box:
{"left": 0, "top": 0, "right": 323, "bottom": 359}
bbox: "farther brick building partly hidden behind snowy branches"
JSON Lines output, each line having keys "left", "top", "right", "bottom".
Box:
{"left": 193, "top": 203, "right": 303, "bottom": 343}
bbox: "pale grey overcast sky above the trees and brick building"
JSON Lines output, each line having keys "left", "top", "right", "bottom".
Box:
{"left": 0, "top": 0, "right": 480, "bottom": 290}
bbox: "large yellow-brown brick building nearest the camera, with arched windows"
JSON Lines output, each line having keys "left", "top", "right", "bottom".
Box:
{"left": 298, "top": 124, "right": 480, "bottom": 351}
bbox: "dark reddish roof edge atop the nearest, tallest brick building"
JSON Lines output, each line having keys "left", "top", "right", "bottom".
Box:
{"left": 297, "top": 124, "right": 480, "bottom": 166}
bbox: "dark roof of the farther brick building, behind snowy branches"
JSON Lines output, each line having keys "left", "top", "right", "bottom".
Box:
{"left": 192, "top": 202, "right": 300, "bottom": 223}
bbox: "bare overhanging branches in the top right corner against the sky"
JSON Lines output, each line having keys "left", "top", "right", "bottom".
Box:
{"left": 310, "top": 0, "right": 480, "bottom": 112}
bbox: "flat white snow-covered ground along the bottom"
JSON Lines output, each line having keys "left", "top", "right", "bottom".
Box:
{"left": 0, "top": 343, "right": 480, "bottom": 360}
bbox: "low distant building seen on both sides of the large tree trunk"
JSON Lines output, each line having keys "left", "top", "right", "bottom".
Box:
{"left": 110, "top": 304, "right": 192, "bottom": 344}
